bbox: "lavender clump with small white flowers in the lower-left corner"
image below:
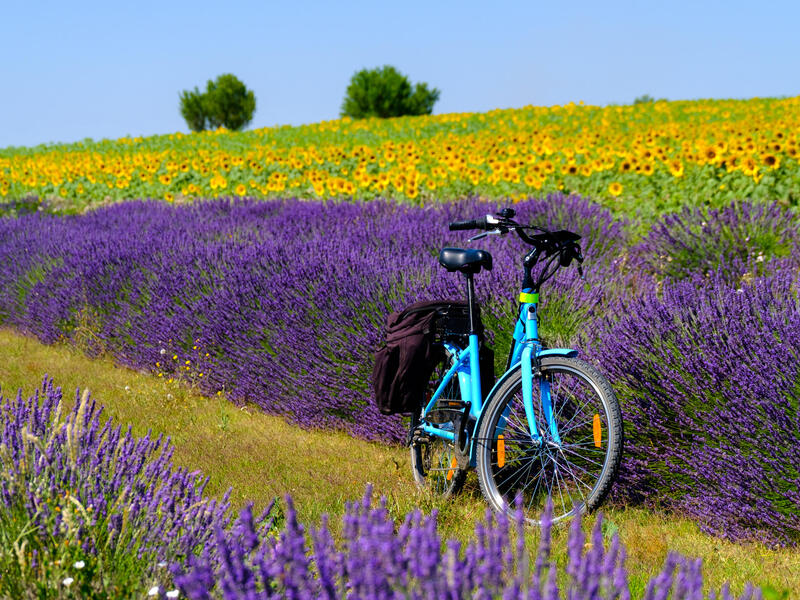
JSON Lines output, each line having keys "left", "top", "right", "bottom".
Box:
{"left": 0, "top": 379, "right": 253, "bottom": 598}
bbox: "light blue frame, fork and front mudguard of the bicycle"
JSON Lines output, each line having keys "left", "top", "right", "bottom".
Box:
{"left": 420, "top": 288, "right": 578, "bottom": 467}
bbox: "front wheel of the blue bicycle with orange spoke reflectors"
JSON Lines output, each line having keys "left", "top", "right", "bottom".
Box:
{"left": 475, "top": 357, "right": 623, "bottom": 524}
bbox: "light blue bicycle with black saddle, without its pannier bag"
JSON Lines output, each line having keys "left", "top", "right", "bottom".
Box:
{"left": 409, "top": 208, "right": 623, "bottom": 524}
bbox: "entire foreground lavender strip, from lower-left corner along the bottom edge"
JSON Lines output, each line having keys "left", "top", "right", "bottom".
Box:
{"left": 0, "top": 380, "right": 761, "bottom": 600}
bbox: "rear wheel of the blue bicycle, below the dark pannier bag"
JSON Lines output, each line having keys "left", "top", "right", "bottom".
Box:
{"left": 411, "top": 353, "right": 467, "bottom": 498}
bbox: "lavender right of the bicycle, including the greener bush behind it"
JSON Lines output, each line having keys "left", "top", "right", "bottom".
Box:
{"left": 586, "top": 202, "right": 800, "bottom": 544}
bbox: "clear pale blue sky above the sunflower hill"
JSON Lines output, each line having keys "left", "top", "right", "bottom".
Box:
{"left": 0, "top": 0, "right": 800, "bottom": 147}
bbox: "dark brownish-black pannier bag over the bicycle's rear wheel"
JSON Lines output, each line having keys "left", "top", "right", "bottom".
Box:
{"left": 372, "top": 300, "right": 494, "bottom": 415}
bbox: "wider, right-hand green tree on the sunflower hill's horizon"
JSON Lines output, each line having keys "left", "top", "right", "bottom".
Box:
{"left": 341, "top": 65, "right": 440, "bottom": 119}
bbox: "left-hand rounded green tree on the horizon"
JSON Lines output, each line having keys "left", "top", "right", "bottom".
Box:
{"left": 180, "top": 73, "right": 256, "bottom": 131}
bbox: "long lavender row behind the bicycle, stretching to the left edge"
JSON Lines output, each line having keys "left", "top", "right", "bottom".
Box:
{"left": 0, "top": 196, "right": 622, "bottom": 440}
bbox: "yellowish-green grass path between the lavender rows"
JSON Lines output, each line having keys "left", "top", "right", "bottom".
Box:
{"left": 0, "top": 329, "right": 800, "bottom": 598}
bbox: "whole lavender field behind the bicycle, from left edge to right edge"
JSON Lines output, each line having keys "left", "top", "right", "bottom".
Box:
{"left": 0, "top": 196, "right": 800, "bottom": 544}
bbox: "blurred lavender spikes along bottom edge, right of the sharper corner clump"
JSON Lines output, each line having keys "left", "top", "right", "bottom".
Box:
{"left": 173, "top": 489, "right": 761, "bottom": 600}
